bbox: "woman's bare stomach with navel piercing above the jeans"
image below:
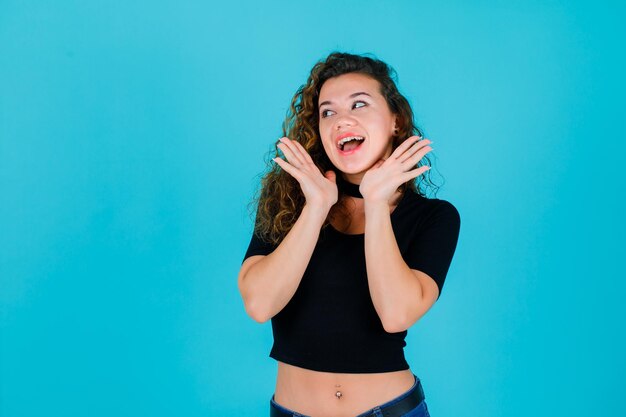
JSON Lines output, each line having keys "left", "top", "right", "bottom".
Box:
{"left": 274, "top": 361, "right": 415, "bottom": 417}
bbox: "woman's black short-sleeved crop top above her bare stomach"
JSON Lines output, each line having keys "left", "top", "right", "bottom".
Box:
{"left": 242, "top": 189, "right": 461, "bottom": 373}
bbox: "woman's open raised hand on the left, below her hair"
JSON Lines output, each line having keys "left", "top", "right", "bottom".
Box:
{"left": 273, "top": 137, "right": 339, "bottom": 211}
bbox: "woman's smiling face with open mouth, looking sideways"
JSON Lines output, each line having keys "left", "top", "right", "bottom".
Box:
{"left": 318, "top": 73, "right": 396, "bottom": 184}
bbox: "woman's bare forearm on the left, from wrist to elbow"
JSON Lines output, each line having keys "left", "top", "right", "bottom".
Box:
{"left": 239, "top": 205, "right": 328, "bottom": 323}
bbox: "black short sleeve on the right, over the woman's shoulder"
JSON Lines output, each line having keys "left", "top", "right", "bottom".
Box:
{"left": 404, "top": 200, "right": 461, "bottom": 299}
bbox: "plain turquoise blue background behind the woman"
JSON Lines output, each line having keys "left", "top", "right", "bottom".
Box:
{"left": 0, "top": 0, "right": 626, "bottom": 417}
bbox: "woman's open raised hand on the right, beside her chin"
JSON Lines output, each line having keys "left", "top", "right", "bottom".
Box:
{"left": 359, "top": 136, "right": 432, "bottom": 204}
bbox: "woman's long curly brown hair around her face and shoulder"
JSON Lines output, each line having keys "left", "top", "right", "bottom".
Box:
{"left": 249, "top": 52, "right": 439, "bottom": 245}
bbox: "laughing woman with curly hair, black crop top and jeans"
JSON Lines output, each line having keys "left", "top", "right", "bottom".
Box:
{"left": 238, "top": 52, "right": 460, "bottom": 417}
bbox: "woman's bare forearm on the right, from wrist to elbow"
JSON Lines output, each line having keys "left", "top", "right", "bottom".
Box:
{"left": 365, "top": 201, "right": 422, "bottom": 332}
